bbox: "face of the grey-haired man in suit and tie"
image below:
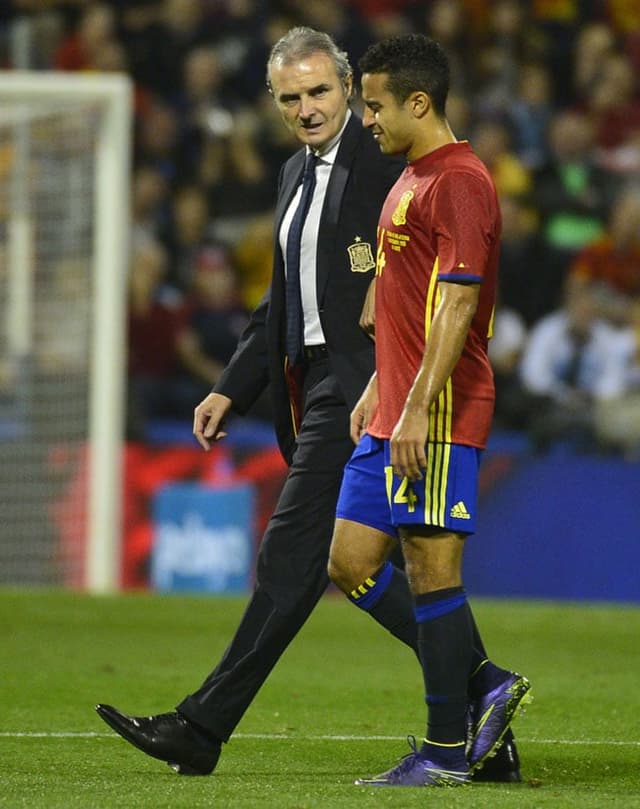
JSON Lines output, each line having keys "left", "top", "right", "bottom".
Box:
{"left": 269, "top": 51, "right": 352, "bottom": 149}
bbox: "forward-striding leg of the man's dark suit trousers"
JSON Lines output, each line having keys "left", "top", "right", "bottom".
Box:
{"left": 177, "top": 359, "right": 353, "bottom": 741}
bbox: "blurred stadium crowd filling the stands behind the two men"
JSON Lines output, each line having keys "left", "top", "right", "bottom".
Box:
{"left": 0, "top": 0, "right": 640, "bottom": 456}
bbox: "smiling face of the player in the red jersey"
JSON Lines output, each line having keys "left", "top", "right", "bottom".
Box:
{"left": 362, "top": 73, "right": 413, "bottom": 157}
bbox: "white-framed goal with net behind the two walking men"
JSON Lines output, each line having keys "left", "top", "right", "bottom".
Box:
{"left": 0, "top": 71, "right": 131, "bottom": 591}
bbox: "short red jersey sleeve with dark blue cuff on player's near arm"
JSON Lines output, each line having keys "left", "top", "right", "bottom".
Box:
{"left": 433, "top": 172, "right": 499, "bottom": 283}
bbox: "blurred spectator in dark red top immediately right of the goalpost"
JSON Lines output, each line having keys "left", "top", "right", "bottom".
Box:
{"left": 127, "top": 242, "right": 191, "bottom": 440}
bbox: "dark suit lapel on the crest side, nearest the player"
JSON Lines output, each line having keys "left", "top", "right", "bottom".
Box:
{"left": 316, "top": 113, "right": 362, "bottom": 306}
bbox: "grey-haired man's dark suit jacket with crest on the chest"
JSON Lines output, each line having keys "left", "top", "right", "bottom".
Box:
{"left": 214, "top": 114, "right": 405, "bottom": 463}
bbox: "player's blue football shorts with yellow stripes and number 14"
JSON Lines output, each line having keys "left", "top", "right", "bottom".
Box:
{"left": 336, "top": 433, "right": 481, "bottom": 537}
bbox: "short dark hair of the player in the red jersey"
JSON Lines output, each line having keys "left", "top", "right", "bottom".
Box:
{"left": 358, "top": 34, "right": 450, "bottom": 116}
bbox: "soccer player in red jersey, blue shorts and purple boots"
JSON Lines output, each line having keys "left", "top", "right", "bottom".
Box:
{"left": 329, "top": 34, "right": 530, "bottom": 786}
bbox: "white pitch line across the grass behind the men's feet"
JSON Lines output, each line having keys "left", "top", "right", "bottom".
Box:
{"left": 0, "top": 731, "right": 640, "bottom": 747}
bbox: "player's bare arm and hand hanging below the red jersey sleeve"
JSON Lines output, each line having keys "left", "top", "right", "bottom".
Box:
{"left": 390, "top": 282, "right": 480, "bottom": 480}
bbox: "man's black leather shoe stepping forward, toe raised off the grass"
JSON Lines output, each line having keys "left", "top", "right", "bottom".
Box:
{"left": 96, "top": 705, "right": 222, "bottom": 775}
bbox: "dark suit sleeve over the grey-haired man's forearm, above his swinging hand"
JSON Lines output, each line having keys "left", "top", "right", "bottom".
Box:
{"left": 213, "top": 290, "right": 270, "bottom": 414}
